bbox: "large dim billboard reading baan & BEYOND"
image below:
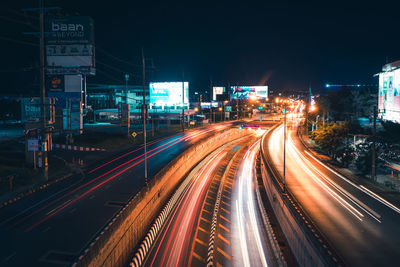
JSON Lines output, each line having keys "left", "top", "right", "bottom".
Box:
{"left": 46, "top": 16, "right": 95, "bottom": 75}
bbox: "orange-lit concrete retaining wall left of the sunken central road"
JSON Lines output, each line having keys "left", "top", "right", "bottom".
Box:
{"left": 74, "top": 129, "right": 247, "bottom": 267}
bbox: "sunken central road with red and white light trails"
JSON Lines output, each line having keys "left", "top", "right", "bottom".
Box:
{"left": 144, "top": 126, "right": 276, "bottom": 266}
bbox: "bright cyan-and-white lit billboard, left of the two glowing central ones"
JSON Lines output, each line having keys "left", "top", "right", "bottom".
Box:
{"left": 150, "top": 82, "right": 189, "bottom": 106}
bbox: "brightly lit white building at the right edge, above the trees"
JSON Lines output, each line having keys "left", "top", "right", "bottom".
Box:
{"left": 377, "top": 60, "right": 400, "bottom": 123}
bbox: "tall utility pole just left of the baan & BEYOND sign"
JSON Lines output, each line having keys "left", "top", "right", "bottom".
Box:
{"left": 39, "top": 0, "right": 49, "bottom": 180}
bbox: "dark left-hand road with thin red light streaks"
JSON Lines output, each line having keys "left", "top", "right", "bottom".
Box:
{"left": 0, "top": 123, "right": 230, "bottom": 266}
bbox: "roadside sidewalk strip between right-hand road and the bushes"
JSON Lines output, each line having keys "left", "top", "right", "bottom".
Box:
{"left": 297, "top": 127, "right": 400, "bottom": 206}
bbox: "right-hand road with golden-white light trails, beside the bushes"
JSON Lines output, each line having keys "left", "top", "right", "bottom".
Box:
{"left": 262, "top": 124, "right": 400, "bottom": 266}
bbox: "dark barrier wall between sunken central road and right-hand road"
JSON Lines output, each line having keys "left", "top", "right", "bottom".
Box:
{"left": 260, "top": 125, "right": 345, "bottom": 266}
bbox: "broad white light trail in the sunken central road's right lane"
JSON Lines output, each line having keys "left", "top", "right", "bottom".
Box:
{"left": 236, "top": 141, "right": 268, "bottom": 266}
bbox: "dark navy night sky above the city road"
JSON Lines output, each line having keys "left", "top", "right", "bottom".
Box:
{"left": 0, "top": 0, "right": 400, "bottom": 95}
